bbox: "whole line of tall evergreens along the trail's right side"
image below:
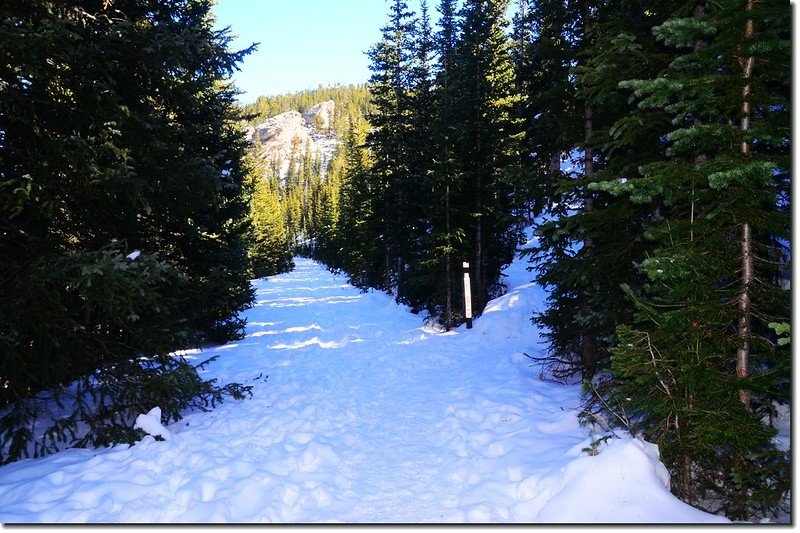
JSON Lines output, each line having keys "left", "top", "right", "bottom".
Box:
{"left": 268, "top": 0, "right": 791, "bottom": 519}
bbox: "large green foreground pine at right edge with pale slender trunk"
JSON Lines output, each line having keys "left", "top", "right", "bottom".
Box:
{"left": 592, "top": 2, "right": 789, "bottom": 519}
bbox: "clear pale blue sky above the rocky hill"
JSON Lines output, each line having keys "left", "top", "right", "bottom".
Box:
{"left": 214, "top": 0, "right": 424, "bottom": 103}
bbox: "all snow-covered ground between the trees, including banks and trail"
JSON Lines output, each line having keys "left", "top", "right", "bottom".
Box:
{"left": 0, "top": 247, "right": 726, "bottom": 523}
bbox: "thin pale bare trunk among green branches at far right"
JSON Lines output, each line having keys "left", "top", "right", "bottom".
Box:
{"left": 736, "top": 0, "right": 755, "bottom": 411}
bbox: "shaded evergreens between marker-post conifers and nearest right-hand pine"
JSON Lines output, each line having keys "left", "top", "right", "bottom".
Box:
{"left": 523, "top": 1, "right": 674, "bottom": 379}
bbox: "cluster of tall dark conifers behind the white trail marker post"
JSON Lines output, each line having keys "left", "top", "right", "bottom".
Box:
{"left": 320, "top": 0, "right": 523, "bottom": 328}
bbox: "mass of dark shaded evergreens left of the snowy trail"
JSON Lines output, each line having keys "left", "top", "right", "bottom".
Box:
{"left": 0, "top": 0, "right": 252, "bottom": 461}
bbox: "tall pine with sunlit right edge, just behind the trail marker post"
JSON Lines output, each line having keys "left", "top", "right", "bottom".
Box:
{"left": 453, "top": 0, "right": 521, "bottom": 314}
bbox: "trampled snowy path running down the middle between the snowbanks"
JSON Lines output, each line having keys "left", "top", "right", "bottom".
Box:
{"left": 198, "top": 260, "right": 585, "bottom": 522}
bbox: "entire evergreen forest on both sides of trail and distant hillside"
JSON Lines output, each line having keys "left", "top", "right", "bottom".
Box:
{"left": 0, "top": 0, "right": 791, "bottom": 519}
